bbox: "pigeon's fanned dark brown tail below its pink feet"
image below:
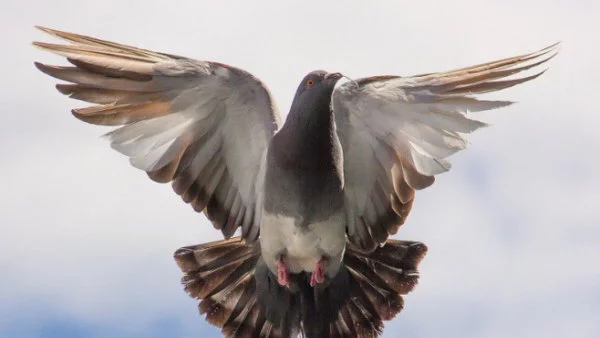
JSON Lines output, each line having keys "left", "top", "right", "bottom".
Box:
{"left": 175, "top": 238, "right": 427, "bottom": 338}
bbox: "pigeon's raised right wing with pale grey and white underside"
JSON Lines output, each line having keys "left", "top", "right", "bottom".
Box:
{"left": 332, "top": 44, "right": 558, "bottom": 251}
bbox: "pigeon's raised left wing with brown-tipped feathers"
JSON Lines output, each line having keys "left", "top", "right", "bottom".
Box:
{"left": 34, "top": 27, "right": 280, "bottom": 241}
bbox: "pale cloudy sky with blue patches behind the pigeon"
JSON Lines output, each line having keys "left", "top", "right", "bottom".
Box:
{"left": 0, "top": 0, "right": 600, "bottom": 338}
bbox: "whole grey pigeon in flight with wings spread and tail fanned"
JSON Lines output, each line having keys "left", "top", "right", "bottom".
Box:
{"left": 34, "top": 27, "right": 559, "bottom": 338}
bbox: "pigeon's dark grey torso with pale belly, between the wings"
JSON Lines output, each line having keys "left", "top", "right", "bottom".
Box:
{"left": 260, "top": 71, "right": 346, "bottom": 282}
